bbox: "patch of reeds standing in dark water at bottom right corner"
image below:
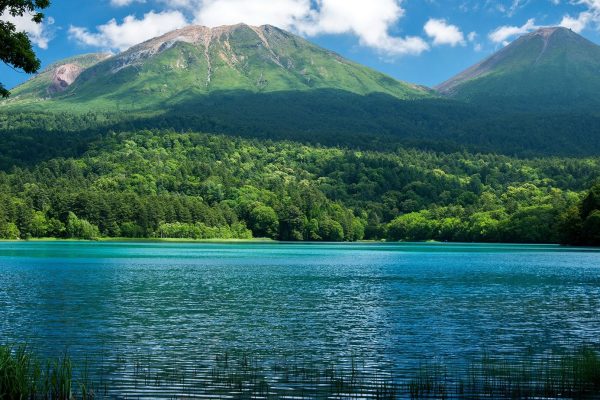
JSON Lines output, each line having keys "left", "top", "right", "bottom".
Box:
{"left": 408, "top": 347, "right": 600, "bottom": 399}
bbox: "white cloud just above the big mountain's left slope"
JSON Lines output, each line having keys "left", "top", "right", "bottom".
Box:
{"left": 69, "top": 11, "right": 187, "bottom": 50}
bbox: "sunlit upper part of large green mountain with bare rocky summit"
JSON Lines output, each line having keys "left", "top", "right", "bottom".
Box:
{"left": 2, "top": 24, "right": 430, "bottom": 110}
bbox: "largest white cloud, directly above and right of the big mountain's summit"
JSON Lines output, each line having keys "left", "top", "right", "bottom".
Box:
{"left": 193, "top": 0, "right": 429, "bottom": 55}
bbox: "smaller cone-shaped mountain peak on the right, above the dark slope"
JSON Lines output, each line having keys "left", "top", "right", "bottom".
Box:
{"left": 435, "top": 27, "right": 600, "bottom": 111}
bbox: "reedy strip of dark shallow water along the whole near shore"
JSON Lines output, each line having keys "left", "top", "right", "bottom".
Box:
{"left": 0, "top": 347, "right": 600, "bottom": 400}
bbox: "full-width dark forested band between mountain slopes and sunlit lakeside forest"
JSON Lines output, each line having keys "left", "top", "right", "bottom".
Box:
{"left": 0, "top": 90, "right": 600, "bottom": 170}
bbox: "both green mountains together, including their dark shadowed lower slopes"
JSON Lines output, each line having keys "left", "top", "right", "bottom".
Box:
{"left": 5, "top": 24, "right": 600, "bottom": 156}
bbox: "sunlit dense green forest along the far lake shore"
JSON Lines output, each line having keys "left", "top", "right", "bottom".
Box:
{"left": 0, "top": 130, "right": 600, "bottom": 244}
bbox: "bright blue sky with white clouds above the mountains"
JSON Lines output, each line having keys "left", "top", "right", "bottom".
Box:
{"left": 0, "top": 0, "right": 600, "bottom": 88}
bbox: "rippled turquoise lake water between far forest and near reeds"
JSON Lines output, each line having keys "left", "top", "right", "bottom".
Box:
{"left": 0, "top": 242, "right": 600, "bottom": 397}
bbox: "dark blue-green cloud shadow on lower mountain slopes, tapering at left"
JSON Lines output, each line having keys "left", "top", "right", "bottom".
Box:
{"left": 136, "top": 90, "right": 600, "bottom": 157}
